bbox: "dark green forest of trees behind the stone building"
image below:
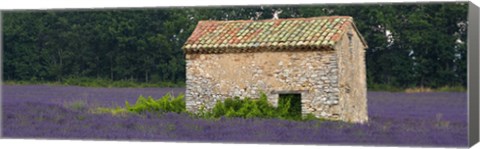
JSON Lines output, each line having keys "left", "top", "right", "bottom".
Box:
{"left": 2, "top": 2, "right": 468, "bottom": 88}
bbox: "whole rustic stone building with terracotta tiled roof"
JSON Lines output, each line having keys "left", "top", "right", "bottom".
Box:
{"left": 183, "top": 16, "right": 368, "bottom": 123}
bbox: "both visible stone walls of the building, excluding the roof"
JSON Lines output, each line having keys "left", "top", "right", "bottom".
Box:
{"left": 185, "top": 16, "right": 368, "bottom": 123}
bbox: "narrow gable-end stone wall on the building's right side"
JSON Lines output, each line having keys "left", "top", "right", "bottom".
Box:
{"left": 335, "top": 27, "right": 368, "bottom": 123}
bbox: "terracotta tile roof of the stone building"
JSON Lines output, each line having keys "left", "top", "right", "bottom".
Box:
{"left": 183, "top": 16, "right": 365, "bottom": 53}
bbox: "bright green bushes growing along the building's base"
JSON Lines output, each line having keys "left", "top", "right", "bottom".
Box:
{"left": 91, "top": 93, "right": 324, "bottom": 121}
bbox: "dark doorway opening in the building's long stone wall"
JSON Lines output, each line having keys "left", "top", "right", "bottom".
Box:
{"left": 278, "top": 94, "right": 302, "bottom": 118}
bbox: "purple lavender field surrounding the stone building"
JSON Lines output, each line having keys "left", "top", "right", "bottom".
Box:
{"left": 2, "top": 85, "right": 467, "bottom": 147}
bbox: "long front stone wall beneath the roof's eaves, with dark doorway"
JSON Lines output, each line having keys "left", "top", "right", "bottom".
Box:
{"left": 185, "top": 50, "right": 341, "bottom": 119}
